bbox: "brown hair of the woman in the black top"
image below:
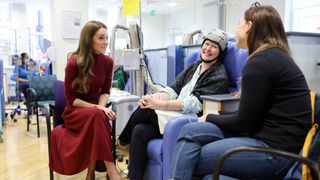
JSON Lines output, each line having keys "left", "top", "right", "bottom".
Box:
{"left": 244, "top": 2, "right": 290, "bottom": 55}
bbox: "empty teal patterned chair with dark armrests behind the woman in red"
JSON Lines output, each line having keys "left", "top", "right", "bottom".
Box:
{"left": 26, "top": 75, "right": 57, "bottom": 137}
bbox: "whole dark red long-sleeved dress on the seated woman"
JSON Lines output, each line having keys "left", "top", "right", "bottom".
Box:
{"left": 49, "top": 54, "right": 113, "bottom": 175}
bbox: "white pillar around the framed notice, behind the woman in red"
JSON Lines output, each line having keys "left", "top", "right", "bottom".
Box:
{"left": 51, "top": 0, "right": 88, "bottom": 80}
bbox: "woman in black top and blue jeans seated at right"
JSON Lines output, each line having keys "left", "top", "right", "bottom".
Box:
{"left": 170, "top": 3, "right": 311, "bottom": 180}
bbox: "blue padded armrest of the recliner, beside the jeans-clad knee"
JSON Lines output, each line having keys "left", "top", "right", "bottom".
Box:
{"left": 162, "top": 116, "right": 197, "bottom": 179}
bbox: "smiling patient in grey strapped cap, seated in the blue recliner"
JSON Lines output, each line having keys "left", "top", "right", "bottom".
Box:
{"left": 119, "top": 29, "right": 229, "bottom": 180}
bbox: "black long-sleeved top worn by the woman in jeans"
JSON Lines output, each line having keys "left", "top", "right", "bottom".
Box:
{"left": 206, "top": 48, "right": 311, "bottom": 153}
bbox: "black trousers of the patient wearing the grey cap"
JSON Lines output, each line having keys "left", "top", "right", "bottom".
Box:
{"left": 119, "top": 108, "right": 162, "bottom": 180}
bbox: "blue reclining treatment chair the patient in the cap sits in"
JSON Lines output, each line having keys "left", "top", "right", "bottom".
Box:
{"left": 144, "top": 42, "right": 248, "bottom": 180}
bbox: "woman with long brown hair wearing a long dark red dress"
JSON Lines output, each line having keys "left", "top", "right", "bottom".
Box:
{"left": 49, "top": 21, "right": 121, "bottom": 180}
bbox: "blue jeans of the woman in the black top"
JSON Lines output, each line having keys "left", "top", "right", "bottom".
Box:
{"left": 169, "top": 122, "right": 291, "bottom": 180}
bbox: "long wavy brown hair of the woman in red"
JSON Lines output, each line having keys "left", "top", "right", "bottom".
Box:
{"left": 72, "top": 21, "right": 107, "bottom": 93}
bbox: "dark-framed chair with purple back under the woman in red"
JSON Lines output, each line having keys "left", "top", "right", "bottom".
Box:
{"left": 45, "top": 80, "right": 116, "bottom": 180}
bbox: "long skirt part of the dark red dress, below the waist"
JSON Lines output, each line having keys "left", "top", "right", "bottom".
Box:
{"left": 49, "top": 106, "right": 113, "bottom": 175}
